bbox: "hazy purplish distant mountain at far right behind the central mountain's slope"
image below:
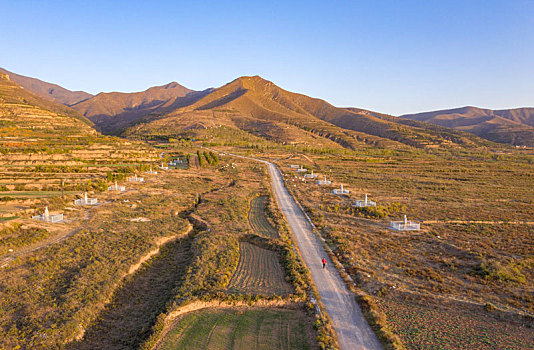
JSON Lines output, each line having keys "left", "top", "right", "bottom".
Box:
{"left": 401, "top": 107, "right": 534, "bottom": 147}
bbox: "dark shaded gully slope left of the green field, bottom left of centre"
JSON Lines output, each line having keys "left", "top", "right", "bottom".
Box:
{"left": 67, "top": 237, "right": 191, "bottom": 350}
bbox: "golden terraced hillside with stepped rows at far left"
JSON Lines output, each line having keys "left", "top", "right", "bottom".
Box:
{"left": 0, "top": 80, "right": 159, "bottom": 219}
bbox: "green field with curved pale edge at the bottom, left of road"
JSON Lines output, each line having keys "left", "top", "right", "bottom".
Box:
{"left": 156, "top": 308, "right": 317, "bottom": 350}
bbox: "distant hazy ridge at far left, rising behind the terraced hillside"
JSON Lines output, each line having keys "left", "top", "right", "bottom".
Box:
{"left": 0, "top": 68, "right": 93, "bottom": 106}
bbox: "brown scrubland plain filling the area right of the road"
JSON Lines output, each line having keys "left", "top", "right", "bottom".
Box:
{"left": 272, "top": 148, "right": 534, "bottom": 349}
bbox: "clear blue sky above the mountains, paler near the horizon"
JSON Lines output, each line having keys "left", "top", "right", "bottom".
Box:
{"left": 0, "top": 0, "right": 534, "bottom": 115}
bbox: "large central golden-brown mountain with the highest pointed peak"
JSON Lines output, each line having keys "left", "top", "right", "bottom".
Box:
{"left": 126, "top": 76, "right": 496, "bottom": 149}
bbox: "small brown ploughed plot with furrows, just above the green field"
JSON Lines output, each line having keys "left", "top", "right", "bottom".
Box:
{"left": 228, "top": 242, "right": 291, "bottom": 295}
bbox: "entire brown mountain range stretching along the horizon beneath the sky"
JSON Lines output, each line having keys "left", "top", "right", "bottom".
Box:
{"left": 3, "top": 70, "right": 534, "bottom": 148}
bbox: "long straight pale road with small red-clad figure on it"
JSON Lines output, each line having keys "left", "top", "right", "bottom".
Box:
{"left": 219, "top": 150, "right": 382, "bottom": 350}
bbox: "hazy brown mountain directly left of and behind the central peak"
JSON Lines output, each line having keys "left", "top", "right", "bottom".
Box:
{"left": 71, "top": 82, "right": 214, "bottom": 133}
